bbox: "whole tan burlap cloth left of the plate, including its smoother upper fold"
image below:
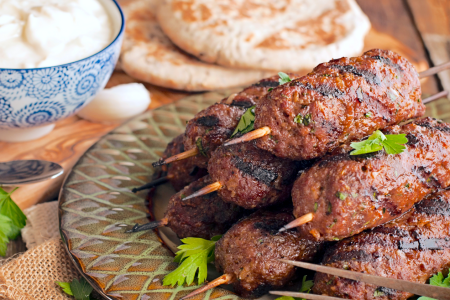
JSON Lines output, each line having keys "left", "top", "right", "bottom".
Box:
{"left": 0, "top": 202, "right": 80, "bottom": 300}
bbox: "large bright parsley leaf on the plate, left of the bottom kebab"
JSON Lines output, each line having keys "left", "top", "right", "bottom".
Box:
{"left": 163, "top": 236, "right": 221, "bottom": 286}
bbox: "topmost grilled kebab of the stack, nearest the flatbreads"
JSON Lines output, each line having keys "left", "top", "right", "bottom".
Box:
{"left": 255, "top": 49, "right": 425, "bottom": 160}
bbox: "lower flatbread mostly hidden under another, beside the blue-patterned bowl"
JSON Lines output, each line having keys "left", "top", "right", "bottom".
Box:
{"left": 119, "top": 0, "right": 273, "bottom": 91}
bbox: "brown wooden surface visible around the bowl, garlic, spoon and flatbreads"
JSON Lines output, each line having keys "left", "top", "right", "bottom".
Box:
{"left": 0, "top": 0, "right": 450, "bottom": 255}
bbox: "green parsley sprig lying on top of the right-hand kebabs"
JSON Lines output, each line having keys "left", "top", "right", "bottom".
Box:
{"left": 350, "top": 130, "right": 408, "bottom": 155}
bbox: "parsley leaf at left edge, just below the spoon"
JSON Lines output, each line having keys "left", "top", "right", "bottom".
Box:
{"left": 0, "top": 187, "right": 27, "bottom": 239}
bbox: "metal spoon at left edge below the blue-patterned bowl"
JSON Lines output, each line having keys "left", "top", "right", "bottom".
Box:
{"left": 0, "top": 160, "right": 64, "bottom": 185}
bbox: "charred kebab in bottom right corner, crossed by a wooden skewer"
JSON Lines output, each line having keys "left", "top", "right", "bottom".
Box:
{"left": 313, "top": 191, "right": 450, "bottom": 300}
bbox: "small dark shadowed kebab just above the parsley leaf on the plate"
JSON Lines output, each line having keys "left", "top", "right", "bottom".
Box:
{"left": 165, "top": 176, "right": 244, "bottom": 239}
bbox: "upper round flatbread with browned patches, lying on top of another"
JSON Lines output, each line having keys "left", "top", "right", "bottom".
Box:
{"left": 158, "top": 0, "right": 370, "bottom": 72}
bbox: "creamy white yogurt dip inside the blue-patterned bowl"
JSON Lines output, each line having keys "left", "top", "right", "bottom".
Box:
{"left": 0, "top": 0, "right": 113, "bottom": 69}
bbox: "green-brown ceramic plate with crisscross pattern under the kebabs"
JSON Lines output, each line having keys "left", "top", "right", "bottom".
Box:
{"left": 60, "top": 91, "right": 450, "bottom": 300}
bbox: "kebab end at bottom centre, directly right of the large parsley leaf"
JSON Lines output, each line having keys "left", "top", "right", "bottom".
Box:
{"left": 215, "top": 210, "right": 321, "bottom": 298}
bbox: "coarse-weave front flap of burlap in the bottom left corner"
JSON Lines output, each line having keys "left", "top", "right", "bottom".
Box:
{"left": 0, "top": 237, "right": 80, "bottom": 300}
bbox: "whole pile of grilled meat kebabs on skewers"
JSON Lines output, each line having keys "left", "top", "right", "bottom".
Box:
{"left": 127, "top": 49, "right": 450, "bottom": 299}
